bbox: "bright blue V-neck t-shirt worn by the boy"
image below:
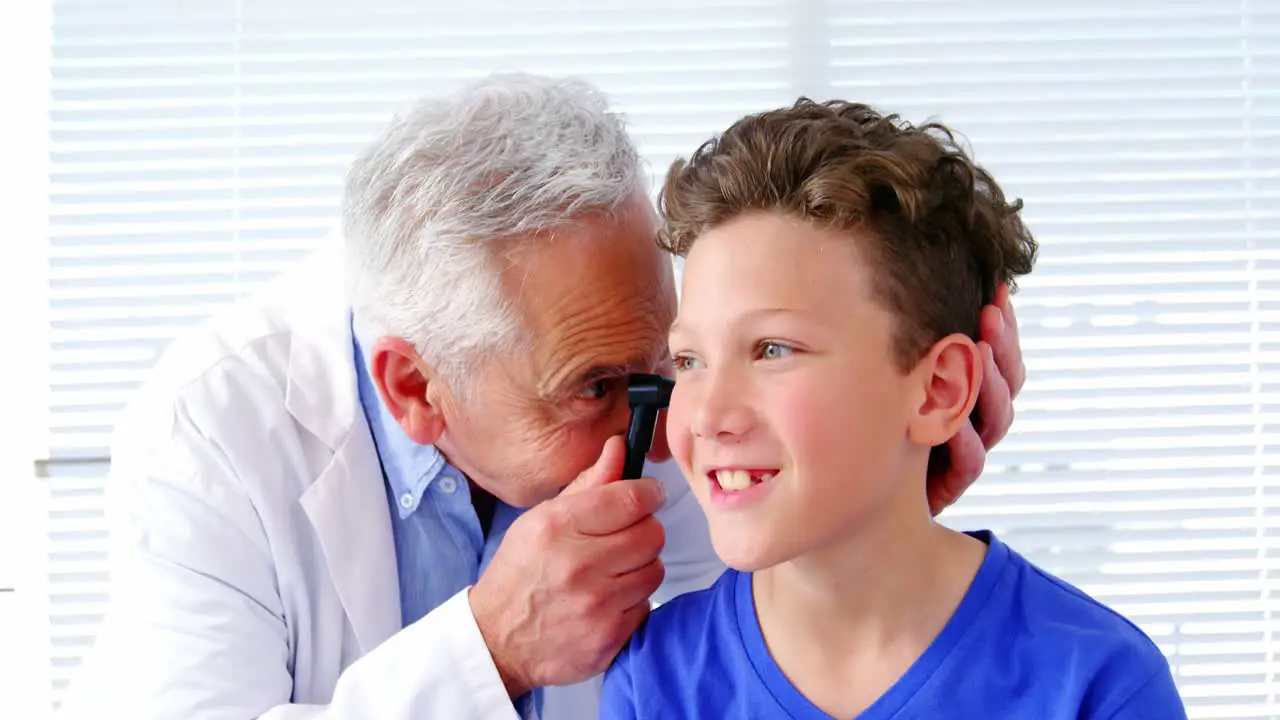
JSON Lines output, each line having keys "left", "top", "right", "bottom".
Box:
{"left": 600, "top": 532, "right": 1187, "bottom": 720}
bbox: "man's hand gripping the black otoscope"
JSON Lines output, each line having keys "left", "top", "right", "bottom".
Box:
{"left": 470, "top": 437, "right": 666, "bottom": 698}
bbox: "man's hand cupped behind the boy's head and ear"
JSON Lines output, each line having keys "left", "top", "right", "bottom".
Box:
{"left": 928, "top": 284, "right": 1027, "bottom": 515}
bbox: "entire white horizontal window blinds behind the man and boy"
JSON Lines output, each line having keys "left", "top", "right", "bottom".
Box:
{"left": 40, "top": 0, "right": 1280, "bottom": 719}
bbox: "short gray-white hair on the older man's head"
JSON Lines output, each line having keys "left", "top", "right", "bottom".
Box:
{"left": 343, "top": 74, "right": 644, "bottom": 389}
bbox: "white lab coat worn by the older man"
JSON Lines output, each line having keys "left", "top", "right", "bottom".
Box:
{"left": 60, "top": 243, "right": 723, "bottom": 720}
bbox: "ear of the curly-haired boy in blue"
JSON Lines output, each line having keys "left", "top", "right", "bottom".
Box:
{"left": 908, "top": 333, "right": 982, "bottom": 447}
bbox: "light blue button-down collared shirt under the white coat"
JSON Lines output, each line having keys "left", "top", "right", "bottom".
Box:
{"left": 352, "top": 328, "right": 541, "bottom": 717}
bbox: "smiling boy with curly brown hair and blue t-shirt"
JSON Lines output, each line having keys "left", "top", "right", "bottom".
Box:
{"left": 602, "top": 100, "right": 1185, "bottom": 720}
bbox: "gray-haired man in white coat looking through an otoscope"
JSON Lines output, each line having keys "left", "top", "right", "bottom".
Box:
{"left": 55, "top": 76, "right": 1023, "bottom": 720}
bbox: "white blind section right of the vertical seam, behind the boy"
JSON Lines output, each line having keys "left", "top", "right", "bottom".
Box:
{"left": 828, "top": 0, "right": 1280, "bottom": 719}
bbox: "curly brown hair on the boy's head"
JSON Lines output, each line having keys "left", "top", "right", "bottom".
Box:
{"left": 658, "top": 97, "right": 1037, "bottom": 370}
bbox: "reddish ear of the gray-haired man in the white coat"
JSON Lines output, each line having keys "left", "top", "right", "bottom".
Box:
{"left": 369, "top": 336, "right": 447, "bottom": 445}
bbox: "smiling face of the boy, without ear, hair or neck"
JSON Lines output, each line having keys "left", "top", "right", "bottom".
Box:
{"left": 667, "top": 213, "right": 928, "bottom": 570}
